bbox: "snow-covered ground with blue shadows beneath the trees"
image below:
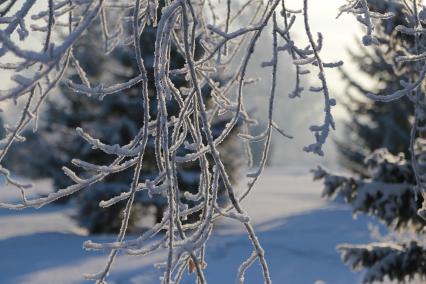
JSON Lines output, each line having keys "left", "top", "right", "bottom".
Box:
{"left": 0, "top": 169, "right": 376, "bottom": 284}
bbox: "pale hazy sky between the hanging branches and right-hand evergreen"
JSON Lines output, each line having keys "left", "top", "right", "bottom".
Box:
{"left": 240, "top": 0, "right": 362, "bottom": 166}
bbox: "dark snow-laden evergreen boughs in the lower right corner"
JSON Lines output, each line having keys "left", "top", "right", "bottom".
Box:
{"left": 313, "top": 143, "right": 426, "bottom": 283}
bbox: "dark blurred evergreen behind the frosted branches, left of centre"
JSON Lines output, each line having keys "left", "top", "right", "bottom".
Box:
{"left": 7, "top": 22, "right": 240, "bottom": 233}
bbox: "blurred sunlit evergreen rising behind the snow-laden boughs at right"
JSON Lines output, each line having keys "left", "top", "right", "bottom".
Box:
{"left": 336, "top": 0, "right": 414, "bottom": 175}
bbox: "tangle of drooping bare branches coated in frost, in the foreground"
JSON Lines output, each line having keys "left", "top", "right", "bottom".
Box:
{"left": 0, "top": 0, "right": 426, "bottom": 283}
